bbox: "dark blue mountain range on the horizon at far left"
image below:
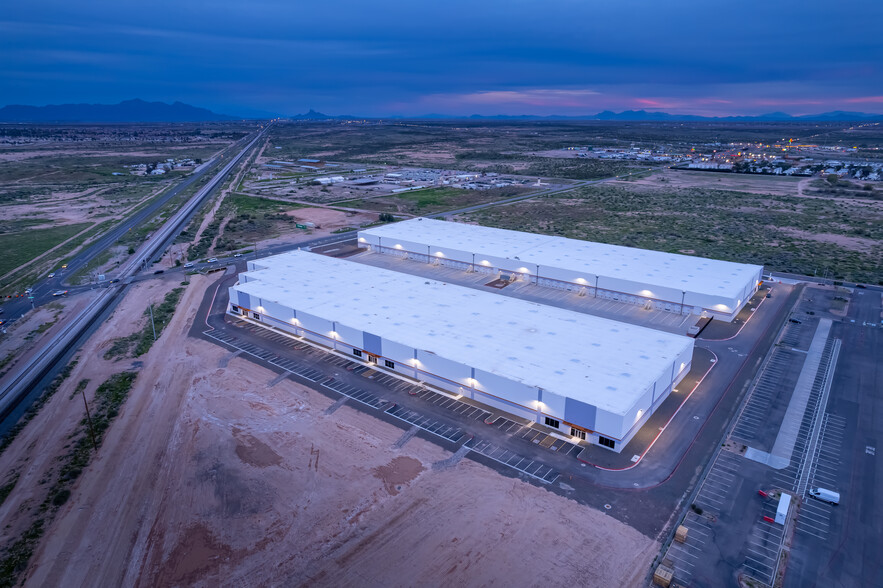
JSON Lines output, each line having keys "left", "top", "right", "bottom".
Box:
{"left": 0, "top": 99, "right": 240, "bottom": 123}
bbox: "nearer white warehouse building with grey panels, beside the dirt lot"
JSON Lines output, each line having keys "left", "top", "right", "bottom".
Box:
{"left": 229, "top": 251, "right": 693, "bottom": 451}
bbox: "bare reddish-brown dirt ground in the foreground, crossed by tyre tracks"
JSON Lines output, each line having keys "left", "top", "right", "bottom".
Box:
{"left": 0, "top": 277, "right": 658, "bottom": 586}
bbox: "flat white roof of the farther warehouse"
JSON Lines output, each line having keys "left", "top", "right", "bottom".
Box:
{"left": 361, "top": 218, "right": 762, "bottom": 299}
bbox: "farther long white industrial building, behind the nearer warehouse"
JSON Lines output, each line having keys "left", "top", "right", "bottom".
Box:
{"left": 359, "top": 218, "right": 763, "bottom": 321}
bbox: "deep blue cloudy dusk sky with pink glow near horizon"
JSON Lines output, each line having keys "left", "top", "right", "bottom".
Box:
{"left": 0, "top": 0, "right": 883, "bottom": 116}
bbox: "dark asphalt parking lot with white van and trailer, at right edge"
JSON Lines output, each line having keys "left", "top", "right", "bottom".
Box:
{"left": 664, "top": 288, "right": 883, "bottom": 587}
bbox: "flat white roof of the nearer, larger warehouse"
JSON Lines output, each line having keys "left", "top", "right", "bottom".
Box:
{"left": 234, "top": 251, "right": 693, "bottom": 415}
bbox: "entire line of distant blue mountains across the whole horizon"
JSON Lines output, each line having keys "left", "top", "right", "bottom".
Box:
{"left": 0, "top": 99, "right": 883, "bottom": 123}
